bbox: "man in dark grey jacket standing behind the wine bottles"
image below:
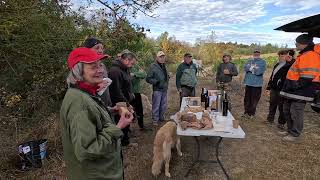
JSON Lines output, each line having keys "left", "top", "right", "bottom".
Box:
{"left": 216, "top": 54, "right": 238, "bottom": 89}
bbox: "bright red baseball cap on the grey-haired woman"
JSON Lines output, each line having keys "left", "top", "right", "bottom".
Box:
{"left": 67, "top": 47, "right": 108, "bottom": 69}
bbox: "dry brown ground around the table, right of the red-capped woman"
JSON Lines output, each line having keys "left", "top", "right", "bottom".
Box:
{"left": 124, "top": 75, "right": 320, "bottom": 180}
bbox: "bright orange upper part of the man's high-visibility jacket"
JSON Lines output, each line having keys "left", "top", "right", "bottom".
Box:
{"left": 287, "top": 51, "right": 320, "bottom": 82}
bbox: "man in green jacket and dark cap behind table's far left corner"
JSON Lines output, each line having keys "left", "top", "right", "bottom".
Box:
{"left": 176, "top": 53, "right": 197, "bottom": 104}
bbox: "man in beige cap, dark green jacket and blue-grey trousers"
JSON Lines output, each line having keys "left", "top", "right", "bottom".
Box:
{"left": 146, "top": 51, "right": 169, "bottom": 126}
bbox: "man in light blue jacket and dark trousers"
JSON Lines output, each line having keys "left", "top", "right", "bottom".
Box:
{"left": 243, "top": 49, "right": 266, "bottom": 119}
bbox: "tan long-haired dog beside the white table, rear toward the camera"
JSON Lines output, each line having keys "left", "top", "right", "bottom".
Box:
{"left": 152, "top": 121, "right": 182, "bottom": 177}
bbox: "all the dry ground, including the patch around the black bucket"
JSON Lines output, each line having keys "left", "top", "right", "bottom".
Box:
{"left": 0, "top": 71, "right": 320, "bottom": 180}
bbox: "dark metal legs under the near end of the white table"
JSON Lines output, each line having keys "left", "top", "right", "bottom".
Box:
{"left": 184, "top": 136, "right": 230, "bottom": 180}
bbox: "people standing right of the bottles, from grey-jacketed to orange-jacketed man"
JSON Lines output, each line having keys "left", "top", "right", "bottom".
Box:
{"left": 216, "top": 34, "right": 320, "bottom": 141}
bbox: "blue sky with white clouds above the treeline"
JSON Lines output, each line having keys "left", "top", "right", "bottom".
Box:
{"left": 71, "top": 0, "right": 320, "bottom": 47}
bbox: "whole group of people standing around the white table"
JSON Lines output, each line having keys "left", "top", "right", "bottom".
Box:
{"left": 60, "top": 34, "right": 320, "bottom": 180}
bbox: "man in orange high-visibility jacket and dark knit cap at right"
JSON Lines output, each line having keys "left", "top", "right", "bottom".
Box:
{"left": 280, "top": 34, "right": 320, "bottom": 141}
